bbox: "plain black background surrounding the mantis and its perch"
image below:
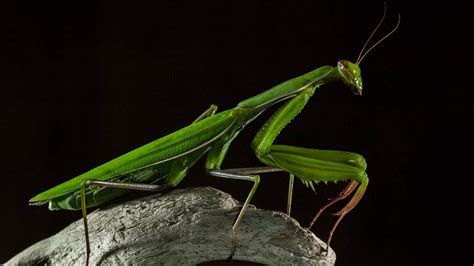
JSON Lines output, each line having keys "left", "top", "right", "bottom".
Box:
{"left": 0, "top": 1, "right": 474, "bottom": 265}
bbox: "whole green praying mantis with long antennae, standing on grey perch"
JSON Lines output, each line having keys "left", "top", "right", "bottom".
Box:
{"left": 30, "top": 7, "right": 400, "bottom": 263}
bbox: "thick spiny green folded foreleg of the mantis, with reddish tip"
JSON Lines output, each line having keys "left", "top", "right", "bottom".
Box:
{"left": 252, "top": 87, "right": 369, "bottom": 250}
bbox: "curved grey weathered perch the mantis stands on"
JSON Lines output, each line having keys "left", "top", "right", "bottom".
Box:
{"left": 6, "top": 187, "right": 336, "bottom": 265}
